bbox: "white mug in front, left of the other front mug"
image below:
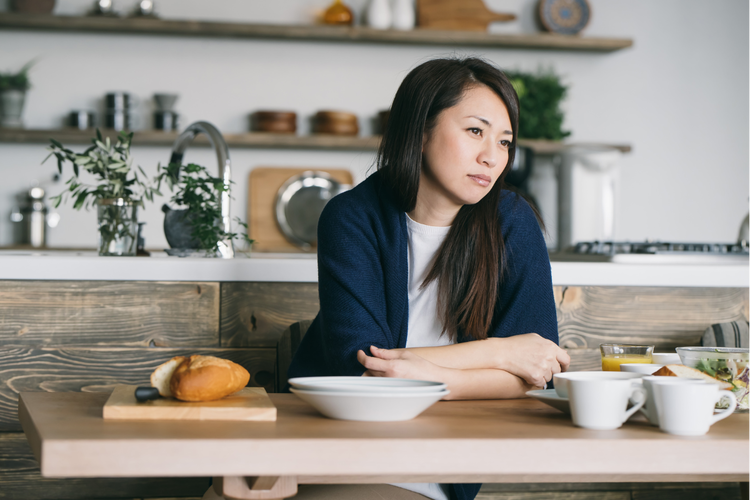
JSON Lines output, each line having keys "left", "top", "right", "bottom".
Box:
{"left": 568, "top": 377, "right": 646, "bottom": 430}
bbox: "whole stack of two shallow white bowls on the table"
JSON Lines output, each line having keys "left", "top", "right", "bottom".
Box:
{"left": 289, "top": 377, "right": 450, "bottom": 422}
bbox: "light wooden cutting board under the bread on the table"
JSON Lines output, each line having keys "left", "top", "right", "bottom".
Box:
{"left": 103, "top": 385, "right": 276, "bottom": 421}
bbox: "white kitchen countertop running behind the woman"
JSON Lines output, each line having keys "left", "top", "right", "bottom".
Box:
{"left": 0, "top": 250, "right": 750, "bottom": 288}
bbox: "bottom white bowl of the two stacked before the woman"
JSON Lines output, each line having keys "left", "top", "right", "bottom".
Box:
{"left": 291, "top": 388, "right": 450, "bottom": 422}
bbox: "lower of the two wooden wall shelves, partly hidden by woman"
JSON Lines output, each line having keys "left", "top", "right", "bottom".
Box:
{"left": 0, "top": 128, "right": 631, "bottom": 154}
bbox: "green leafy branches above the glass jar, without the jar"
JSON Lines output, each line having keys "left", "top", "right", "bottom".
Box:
{"left": 42, "top": 129, "right": 161, "bottom": 210}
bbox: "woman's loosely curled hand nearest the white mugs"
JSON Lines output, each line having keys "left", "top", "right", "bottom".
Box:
{"left": 497, "top": 333, "right": 570, "bottom": 387}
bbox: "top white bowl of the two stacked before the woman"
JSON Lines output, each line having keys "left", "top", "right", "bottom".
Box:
{"left": 289, "top": 377, "right": 448, "bottom": 394}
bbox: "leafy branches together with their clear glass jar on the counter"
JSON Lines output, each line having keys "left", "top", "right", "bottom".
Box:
{"left": 42, "top": 129, "right": 161, "bottom": 256}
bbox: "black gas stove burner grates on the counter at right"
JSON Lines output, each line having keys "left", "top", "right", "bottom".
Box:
{"left": 573, "top": 241, "right": 750, "bottom": 256}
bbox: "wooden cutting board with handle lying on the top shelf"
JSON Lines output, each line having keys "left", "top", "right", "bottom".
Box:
{"left": 417, "top": 0, "right": 516, "bottom": 31}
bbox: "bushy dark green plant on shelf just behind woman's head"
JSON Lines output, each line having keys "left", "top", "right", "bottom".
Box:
{"left": 506, "top": 70, "right": 570, "bottom": 141}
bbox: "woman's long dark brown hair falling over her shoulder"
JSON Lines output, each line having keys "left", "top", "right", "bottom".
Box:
{"left": 377, "top": 58, "right": 518, "bottom": 340}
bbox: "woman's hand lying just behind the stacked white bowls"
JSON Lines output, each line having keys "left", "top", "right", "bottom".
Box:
{"left": 357, "top": 346, "right": 448, "bottom": 382}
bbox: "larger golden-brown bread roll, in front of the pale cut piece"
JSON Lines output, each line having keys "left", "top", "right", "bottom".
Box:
{"left": 169, "top": 355, "right": 250, "bottom": 401}
